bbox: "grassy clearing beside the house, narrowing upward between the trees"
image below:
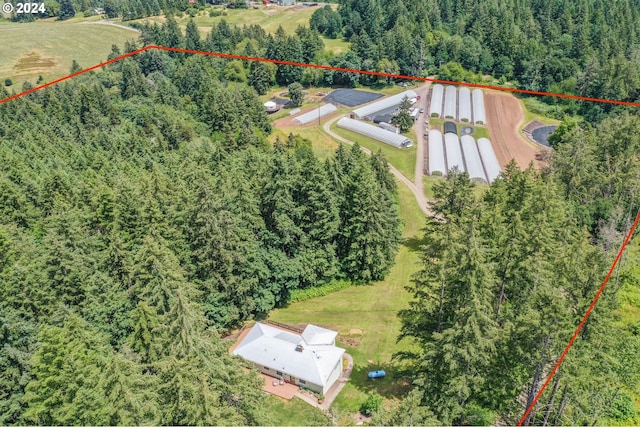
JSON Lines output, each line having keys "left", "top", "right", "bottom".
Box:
{"left": 269, "top": 178, "right": 424, "bottom": 422}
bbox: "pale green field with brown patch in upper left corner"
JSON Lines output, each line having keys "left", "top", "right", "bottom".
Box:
{"left": 0, "top": 21, "right": 138, "bottom": 87}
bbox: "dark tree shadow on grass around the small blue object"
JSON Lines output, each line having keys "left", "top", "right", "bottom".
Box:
{"left": 349, "top": 362, "right": 411, "bottom": 399}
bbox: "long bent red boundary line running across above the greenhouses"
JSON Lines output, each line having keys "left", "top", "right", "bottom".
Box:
{"left": 0, "top": 45, "right": 640, "bottom": 107}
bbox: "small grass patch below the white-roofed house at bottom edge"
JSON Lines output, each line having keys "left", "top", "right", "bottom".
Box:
{"left": 262, "top": 395, "right": 331, "bottom": 426}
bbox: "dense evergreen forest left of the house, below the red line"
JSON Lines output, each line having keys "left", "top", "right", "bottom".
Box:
{"left": 0, "top": 20, "right": 401, "bottom": 425}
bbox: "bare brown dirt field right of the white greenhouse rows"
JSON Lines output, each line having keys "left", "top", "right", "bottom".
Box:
{"left": 484, "top": 91, "right": 541, "bottom": 168}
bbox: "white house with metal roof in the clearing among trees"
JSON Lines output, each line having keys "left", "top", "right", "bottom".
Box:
{"left": 232, "top": 322, "right": 344, "bottom": 394}
